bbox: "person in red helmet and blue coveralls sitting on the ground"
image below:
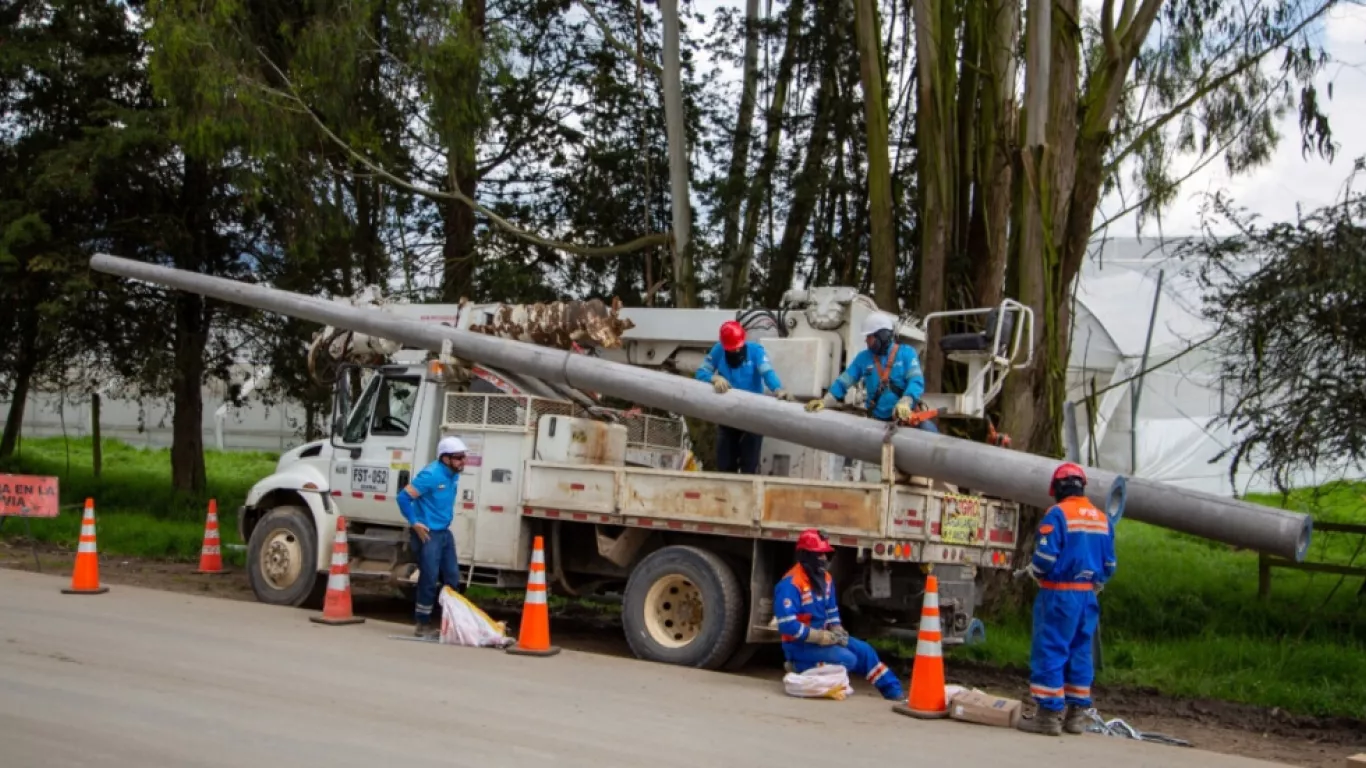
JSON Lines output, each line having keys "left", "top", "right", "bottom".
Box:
{"left": 773, "top": 529, "right": 906, "bottom": 701}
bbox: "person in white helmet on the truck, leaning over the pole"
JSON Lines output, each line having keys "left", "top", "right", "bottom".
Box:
{"left": 806, "top": 312, "right": 938, "bottom": 432}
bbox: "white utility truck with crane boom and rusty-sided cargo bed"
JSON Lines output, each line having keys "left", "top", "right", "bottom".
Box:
{"left": 238, "top": 288, "right": 1033, "bottom": 668}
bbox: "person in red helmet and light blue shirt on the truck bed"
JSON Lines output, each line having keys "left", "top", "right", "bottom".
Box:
{"left": 695, "top": 320, "right": 792, "bottom": 474}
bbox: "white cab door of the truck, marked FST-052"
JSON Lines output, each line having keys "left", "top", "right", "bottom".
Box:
{"left": 332, "top": 368, "right": 420, "bottom": 525}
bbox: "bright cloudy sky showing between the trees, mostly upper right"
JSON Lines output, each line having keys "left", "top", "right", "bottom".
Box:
{"left": 690, "top": 0, "right": 1366, "bottom": 239}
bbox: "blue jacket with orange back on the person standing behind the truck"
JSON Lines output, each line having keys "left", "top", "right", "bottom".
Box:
{"left": 1030, "top": 496, "right": 1117, "bottom": 589}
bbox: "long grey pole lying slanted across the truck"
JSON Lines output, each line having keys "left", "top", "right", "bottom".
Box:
{"left": 90, "top": 254, "right": 1313, "bottom": 562}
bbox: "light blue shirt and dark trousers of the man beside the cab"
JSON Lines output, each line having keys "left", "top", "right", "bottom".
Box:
{"left": 398, "top": 461, "right": 460, "bottom": 622}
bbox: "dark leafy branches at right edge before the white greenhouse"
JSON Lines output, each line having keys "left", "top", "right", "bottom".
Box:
{"left": 1182, "top": 160, "right": 1366, "bottom": 489}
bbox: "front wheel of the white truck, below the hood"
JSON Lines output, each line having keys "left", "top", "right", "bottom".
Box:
{"left": 247, "top": 506, "right": 328, "bottom": 607}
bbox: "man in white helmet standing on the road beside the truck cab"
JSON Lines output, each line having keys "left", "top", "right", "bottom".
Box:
{"left": 398, "top": 437, "right": 469, "bottom": 637}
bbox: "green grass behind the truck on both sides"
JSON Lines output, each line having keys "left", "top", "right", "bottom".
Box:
{"left": 8, "top": 439, "right": 1366, "bottom": 719}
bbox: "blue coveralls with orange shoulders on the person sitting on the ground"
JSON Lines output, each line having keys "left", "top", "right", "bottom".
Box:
{"left": 773, "top": 564, "right": 902, "bottom": 698}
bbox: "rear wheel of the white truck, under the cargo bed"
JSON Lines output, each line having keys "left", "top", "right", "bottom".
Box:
{"left": 622, "top": 547, "right": 746, "bottom": 670}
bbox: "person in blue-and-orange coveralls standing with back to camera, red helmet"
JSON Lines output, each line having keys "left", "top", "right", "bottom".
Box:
{"left": 1015, "top": 462, "right": 1116, "bottom": 737}
